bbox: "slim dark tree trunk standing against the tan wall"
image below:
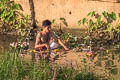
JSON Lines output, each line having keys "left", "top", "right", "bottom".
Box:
{"left": 29, "top": 0, "right": 37, "bottom": 29}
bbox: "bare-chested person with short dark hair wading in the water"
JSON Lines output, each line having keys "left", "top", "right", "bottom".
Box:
{"left": 35, "top": 20, "right": 69, "bottom": 58}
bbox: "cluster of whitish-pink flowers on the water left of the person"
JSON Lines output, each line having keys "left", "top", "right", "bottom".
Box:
{"left": 10, "top": 42, "right": 29, "bottom": 50}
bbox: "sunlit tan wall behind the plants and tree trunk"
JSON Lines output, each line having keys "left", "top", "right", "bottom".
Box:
{"left": 15, "top": 0, "right": 120, "bottom": 28}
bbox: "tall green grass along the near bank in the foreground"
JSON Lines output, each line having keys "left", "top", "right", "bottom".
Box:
{"left": 0, "top": 50, "right": 108, "bottom": 80}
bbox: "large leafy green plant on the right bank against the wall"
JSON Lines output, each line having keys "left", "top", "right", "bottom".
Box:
{"left": 78, "top": 11, "right": 120, "bottom": 46}
